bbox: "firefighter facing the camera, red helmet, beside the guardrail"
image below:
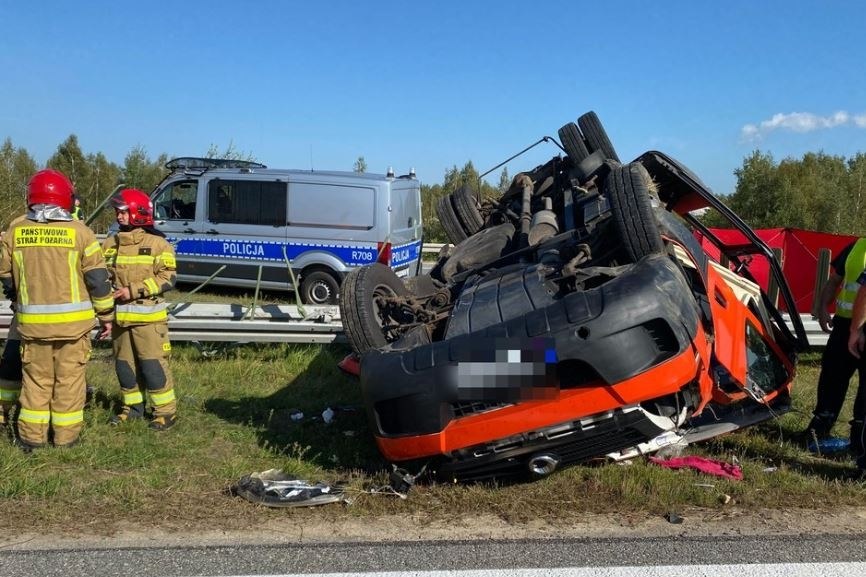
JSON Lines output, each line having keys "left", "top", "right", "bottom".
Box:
{"left": 102, "top": 188, "right": 177, "bottom": 431}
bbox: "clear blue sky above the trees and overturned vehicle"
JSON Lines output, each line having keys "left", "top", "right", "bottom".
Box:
{"left": 0, "top": 0, "right": 866, "bottom": 194}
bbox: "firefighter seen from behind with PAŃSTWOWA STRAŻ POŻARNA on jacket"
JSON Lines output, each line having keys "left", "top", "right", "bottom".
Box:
{"left": 0, "top": 169, "right": 114, "bottom": 453}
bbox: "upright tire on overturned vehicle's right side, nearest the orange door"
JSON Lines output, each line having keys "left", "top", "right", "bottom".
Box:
{"left": 604, "top": 162, "right": 664, "bottom": 262}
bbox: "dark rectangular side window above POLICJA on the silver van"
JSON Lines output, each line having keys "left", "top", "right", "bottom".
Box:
{"left": 208, "top": 179, "right": 286, "bottom": 226}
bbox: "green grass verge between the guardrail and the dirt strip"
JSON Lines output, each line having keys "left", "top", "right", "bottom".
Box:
{"left": 0, "top": 344, "right": 866, "bottom": 533}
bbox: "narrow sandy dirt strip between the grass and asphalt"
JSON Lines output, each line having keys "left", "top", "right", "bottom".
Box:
{"left": 0, "top": 508, "right": 866, "bottom": 550}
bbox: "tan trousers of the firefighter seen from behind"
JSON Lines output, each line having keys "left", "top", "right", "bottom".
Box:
{"left": 18, "top": 334, "right": 90, "bottom": 447}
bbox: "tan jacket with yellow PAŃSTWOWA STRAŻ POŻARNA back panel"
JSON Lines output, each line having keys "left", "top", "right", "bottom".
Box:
{"left": 0, "top": 218, "right": 114, "bottom": 340}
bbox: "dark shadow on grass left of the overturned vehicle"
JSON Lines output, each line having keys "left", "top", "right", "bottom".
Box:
{"left": 204, "top": 346, "right": 387, "bottom": 473}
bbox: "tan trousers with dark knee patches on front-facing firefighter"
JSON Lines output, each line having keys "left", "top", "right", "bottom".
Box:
{"left": 111, "top": 323, "right": 177, "bottom": 417}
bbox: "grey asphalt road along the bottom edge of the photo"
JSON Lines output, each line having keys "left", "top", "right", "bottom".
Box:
{"left": 0, "top": 535, "right": 866, "bottom": 577}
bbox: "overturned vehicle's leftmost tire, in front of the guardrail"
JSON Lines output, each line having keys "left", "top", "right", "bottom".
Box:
{"left": 340, "top": 262, "right": 408, "bottom": 355}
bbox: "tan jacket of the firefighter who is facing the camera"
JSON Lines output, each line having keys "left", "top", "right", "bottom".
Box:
{"left": 102, "top": 228, "right": 177, "bottom": 327}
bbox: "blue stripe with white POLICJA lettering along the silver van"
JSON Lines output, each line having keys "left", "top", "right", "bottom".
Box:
{"left": 168, "top": 237, "right": 421, "bottom": 267}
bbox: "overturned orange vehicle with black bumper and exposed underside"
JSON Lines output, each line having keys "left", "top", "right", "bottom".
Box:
{"left": 340, "top": 112, "right": 806, "bottom": 480}
